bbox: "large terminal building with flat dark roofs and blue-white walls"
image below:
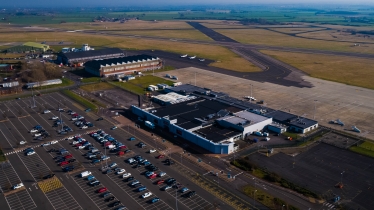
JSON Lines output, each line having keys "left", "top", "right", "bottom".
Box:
{"left": 131, "top": 84, "right": 318, "bottom": 154}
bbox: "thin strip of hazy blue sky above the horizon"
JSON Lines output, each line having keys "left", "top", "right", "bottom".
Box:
{"left": 0, "top": 0, "right": 374, "bottom": 7}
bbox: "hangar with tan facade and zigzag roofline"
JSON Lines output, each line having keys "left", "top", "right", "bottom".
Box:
{"left": 84, "top": 54, "right": 162, "bottom": 77}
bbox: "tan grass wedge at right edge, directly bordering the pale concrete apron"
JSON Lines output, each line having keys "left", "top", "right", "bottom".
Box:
{"left": 261, "top": 50, "right": 374, "bottom": 89}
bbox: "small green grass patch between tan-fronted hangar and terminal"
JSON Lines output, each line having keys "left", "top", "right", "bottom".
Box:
{"left": 112, "top": 75, "right": 173, "bottom": 95}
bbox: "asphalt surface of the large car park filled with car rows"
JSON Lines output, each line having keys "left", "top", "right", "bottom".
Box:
{"left": 0, "top": 93, "right": 231, "bottom": 210}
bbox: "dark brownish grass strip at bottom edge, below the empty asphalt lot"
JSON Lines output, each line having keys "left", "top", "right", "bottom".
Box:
{"left": 242, "top": 185, "right": 298, "bottom": 210}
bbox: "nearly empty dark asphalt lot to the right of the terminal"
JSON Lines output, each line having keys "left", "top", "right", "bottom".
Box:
{"left": 249, "top": 143, "right": 374, "bottom": 209}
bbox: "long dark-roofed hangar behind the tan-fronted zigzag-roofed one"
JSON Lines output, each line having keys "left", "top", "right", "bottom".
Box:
{"left": 57, "top": 46, "right": 124, "bottom": 65}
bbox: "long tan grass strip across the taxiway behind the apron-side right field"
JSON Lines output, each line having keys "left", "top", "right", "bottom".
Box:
{"left": 216, "top": 29, "right": 374, "bottom": 53}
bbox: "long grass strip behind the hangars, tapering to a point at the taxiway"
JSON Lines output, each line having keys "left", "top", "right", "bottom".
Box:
{"left": 1, "top": 29, "right": 260, "bottom": 72}
